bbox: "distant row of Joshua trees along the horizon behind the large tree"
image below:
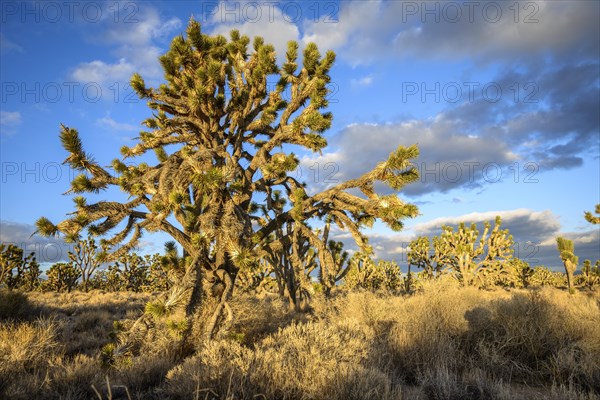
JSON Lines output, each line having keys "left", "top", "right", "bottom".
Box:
{"left": 0, "top": 217, "right": 600, "bottom": 294}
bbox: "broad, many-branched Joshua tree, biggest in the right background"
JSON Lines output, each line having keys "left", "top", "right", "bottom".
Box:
{"left": 433, "top": 217, "right": 513, "bottom": 287}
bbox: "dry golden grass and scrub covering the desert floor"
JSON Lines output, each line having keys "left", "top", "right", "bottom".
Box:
{"left": 0, "top": 282, "right": 600, "bottom": 400}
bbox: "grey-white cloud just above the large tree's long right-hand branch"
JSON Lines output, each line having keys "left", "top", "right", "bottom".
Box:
{"left": 301, "top": 118, "right": 517, "bottom": 196}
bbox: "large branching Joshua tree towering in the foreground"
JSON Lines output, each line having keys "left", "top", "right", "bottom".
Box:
{"left": 37, "top": 20, "right": 418, "bottom": 338}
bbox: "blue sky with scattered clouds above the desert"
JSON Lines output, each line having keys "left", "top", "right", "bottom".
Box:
{"left": 0, "top": 0, "right": 600, "bottom": 268}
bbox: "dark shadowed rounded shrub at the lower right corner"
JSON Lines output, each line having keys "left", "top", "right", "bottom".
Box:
{"left": 464, "top": 290, "right": 600, "bottom": 391}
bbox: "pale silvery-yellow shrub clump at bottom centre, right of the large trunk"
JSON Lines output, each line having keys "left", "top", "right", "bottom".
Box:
{"left": 166, "top": 321, "right": 391, "bottom": 399}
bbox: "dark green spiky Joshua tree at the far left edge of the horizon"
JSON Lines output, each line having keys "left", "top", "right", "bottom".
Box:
{"left": 0, "top": 243, "right": 41, "bottom": 290}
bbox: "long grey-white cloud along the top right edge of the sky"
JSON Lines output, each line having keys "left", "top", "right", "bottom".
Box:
{"left": 303, "top": 0, "right": 600, "bottom": 65}
